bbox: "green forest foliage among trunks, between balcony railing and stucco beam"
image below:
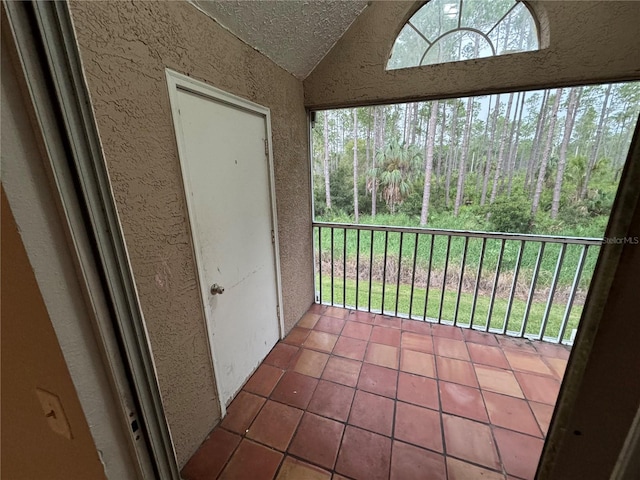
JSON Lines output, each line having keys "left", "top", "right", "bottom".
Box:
{"left": 312, "top": 82, "right": 640, "bottom": 242}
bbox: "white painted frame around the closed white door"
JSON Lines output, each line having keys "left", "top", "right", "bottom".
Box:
{"left": 165, "top": 68, "right": 285, "bottom": 418}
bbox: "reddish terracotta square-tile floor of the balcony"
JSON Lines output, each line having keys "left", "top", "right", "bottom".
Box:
{"left": 182, "top": 305, "right": 569, "bottom": 480}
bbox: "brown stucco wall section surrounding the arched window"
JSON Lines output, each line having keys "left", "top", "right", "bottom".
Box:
{"left": 304, "top": 1, "right": 640, "bottom": 108}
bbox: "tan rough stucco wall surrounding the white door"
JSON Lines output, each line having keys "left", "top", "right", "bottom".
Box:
{"left": 71, "top": 1, "right": 313, "bottom": 465}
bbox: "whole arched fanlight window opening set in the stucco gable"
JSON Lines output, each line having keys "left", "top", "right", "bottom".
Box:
{"left": 387, "top": 0, "right": 539, "bottom": 70}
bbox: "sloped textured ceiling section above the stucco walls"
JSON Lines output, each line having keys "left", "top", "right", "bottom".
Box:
{"left": 190, "top": 0, "right": 368, "bottom": 79}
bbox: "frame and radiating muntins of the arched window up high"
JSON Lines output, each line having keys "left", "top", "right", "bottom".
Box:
{"left": 385, "top": 0, "right": 542, "bottom": 70}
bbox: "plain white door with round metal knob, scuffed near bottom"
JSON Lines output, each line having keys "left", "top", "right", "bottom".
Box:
{"left": 168, "top": 72, "right": 280, "bottom": 415}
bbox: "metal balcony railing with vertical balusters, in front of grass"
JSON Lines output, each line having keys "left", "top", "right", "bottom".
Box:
{"left": 313, "top": 222, "right": 602, "bottom": 344}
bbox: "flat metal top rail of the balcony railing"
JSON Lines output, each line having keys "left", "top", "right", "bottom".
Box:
{"left": 312, "top": 222, "right": 602, "bottom": 245}
